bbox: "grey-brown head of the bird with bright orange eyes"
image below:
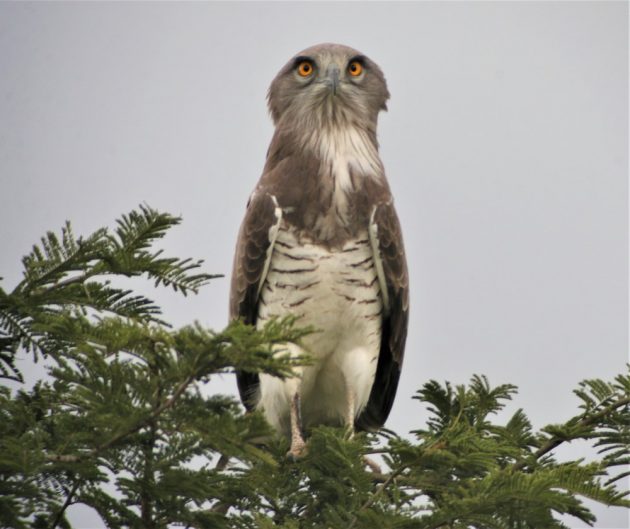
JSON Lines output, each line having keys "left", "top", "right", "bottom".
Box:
{"left": 268, "top": 44, "right": 389, "bottom": 131}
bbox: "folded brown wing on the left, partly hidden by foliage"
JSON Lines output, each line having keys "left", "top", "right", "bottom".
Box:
{"left": 230, "top": 191, "right": 281, "bottom": 410}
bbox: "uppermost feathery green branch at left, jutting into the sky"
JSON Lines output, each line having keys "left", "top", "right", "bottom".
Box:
{"left": 0, "top": 206, "right": 217, "bottom": 380}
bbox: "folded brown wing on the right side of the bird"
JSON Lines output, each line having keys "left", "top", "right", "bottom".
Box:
{"left": 355, "top": 201, "right": 409, "bottom": 430}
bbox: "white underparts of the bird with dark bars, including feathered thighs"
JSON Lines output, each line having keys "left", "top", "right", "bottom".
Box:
{"left": 257, "top": 222, "right": 383, "bottom": 432}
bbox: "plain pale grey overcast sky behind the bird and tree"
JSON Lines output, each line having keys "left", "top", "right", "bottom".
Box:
{"left": 0, "top": 1, "right": 628, "bottom": 529}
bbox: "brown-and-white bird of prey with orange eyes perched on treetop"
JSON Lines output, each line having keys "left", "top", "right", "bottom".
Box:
{"left": 230, "top": 44, "right": 409, "bottom": 457}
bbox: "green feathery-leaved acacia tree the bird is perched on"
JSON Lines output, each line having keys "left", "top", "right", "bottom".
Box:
{"left": 0, "top": 207, "right": 630, "bottom": 529}
